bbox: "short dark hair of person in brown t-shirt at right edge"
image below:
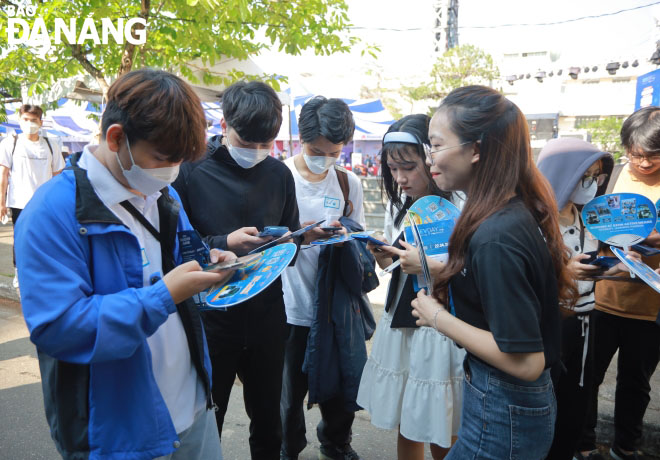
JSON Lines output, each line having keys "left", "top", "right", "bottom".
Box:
{"left": 621, "top": 107, "right": 660, "bottom": 152}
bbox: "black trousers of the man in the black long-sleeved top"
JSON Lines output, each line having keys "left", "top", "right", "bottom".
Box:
{"left": 209, "top": 330, "right": 284, "bottom": 460}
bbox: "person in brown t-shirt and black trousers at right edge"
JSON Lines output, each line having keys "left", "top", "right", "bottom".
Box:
{"left": 577, "top": 107, "right": 660, "bottom": 460}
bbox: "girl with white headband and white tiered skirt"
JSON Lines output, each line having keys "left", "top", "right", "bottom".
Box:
{"left": 357, "top": 114, "right": 465, "bottom": 460}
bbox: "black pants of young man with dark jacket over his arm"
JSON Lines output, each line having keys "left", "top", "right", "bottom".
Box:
{"left": 280, "top": 324, "right": 355, "bottom": 457}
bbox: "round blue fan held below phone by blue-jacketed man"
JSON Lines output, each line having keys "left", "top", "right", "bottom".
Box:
{"left": 200, "top": 243, "right": 296, "bottom": 310}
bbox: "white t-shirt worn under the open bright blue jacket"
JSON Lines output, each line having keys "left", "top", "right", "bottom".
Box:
{"left": 78, "top": 147, "right": 206, "bottom": 433}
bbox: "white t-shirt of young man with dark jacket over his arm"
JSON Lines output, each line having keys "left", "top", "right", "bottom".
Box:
{"left": 282, "top": 156, "right": 365, "bottom": 327}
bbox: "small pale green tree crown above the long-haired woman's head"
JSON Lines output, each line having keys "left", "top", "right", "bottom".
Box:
{"left": 404, "top": 45, "right": 499, "bottom": 100}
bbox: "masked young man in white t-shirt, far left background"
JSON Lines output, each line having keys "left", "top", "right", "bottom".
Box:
{"left": 0, "top": 104, "right": 64, "bottom": 288}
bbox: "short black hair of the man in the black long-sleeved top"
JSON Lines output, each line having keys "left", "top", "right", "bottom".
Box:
{"left": 222, "top": 81, "right": 282, "bottom": 142}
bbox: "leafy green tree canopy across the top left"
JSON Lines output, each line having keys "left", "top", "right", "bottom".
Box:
{"left": 0, "top": 0, "right": 357, "bottom": 110}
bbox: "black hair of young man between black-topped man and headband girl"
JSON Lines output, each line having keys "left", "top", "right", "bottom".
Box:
{"left": 298, "top": 96, "right": 355, "bottom": 144}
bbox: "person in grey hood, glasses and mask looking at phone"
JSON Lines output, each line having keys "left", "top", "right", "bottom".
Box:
{"left": 537, "top": 138, "right": 619, "bottom": 460}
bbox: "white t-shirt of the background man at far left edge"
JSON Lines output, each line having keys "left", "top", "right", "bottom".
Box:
{"left": 0, "top": 135, "right": 64, "bottom": 209}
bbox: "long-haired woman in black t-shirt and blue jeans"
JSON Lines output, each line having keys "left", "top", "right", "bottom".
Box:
{"left": 413, "top": 86, "right": 577, "bottom": 460}
